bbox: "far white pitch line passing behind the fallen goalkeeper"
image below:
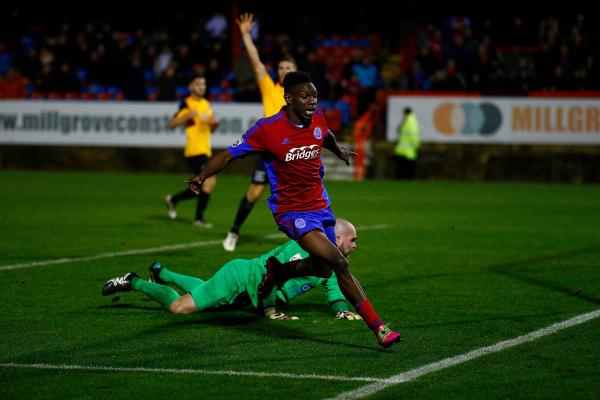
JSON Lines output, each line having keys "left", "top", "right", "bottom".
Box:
{"left": 0, "top": 224, "right": 391, "bottom": 272}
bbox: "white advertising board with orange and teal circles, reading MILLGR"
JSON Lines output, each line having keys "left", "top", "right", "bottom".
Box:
{"left": 386, "top": 96, "right": 600, "bottom": 145}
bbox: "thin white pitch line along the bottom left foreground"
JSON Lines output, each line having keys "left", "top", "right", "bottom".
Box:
{"left": 0, "top": 363, "right": 383, "bottom": 382}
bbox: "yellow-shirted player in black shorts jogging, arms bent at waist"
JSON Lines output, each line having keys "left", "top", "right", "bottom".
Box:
{"left": 165, "top": 76, "right": 219, "bottom": 228}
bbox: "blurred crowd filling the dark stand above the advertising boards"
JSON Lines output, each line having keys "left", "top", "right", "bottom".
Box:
{"left": 0, "top": 5, "right": 600, "bottom": 122}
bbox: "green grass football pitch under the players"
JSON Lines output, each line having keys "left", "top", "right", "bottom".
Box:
{"left": 0, "top": 171, "right": 600, "bottom": 399}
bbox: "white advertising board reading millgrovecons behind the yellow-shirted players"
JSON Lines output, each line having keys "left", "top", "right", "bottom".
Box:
{"left": 0, "top": 101, "right": 263, "bottom": 148}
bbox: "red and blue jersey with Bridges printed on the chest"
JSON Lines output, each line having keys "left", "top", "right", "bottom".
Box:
{"left": 227, "top": 106, "right": 333, "bottom": 214}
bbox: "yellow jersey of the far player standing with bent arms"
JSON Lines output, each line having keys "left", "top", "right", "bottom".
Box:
{"left": 175, "top": 96, "right": 212, "bottom": 157}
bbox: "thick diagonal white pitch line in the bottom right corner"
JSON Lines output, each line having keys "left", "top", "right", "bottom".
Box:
{"left": 329, "top": 309, "right": 600, "bottom": 400}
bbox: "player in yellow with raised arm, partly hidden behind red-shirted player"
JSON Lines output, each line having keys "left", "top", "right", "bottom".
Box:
{"left": 223, "top": 14, "right": 297, "bottom": 251}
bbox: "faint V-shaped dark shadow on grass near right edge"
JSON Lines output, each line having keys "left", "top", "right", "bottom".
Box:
{"left": 489, "top": 246, "right": 600, "bottom": 305}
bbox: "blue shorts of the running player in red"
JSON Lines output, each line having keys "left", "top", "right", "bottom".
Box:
{"left": 275, "top": 207, "right": 335, "bottom": 244}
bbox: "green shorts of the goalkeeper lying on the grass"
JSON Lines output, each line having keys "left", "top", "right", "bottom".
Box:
{"left": 190, "top": 259, "right": 266, "bottom": 311}
